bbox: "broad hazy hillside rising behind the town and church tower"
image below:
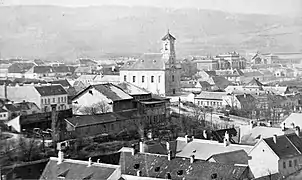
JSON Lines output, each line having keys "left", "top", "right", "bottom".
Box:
{"left": 0, "top": 6, "right": 302, "bottom": 61}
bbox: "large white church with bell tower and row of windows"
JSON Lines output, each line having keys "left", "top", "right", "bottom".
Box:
{"left": 120, "top": 31, "right": 181, "bottom": 96}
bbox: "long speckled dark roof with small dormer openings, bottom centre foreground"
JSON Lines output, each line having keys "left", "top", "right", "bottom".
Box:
{"left": 120, "top": 152, "right": 247, "bottom": 180}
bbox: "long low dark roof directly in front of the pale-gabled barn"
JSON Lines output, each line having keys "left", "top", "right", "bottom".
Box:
{"left": 66, "top": 112, "right": 126, "bottom": 127}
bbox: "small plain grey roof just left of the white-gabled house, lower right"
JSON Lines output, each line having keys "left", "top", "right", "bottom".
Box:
{"left": 209, "top": 150, "right": 249, "bottom": 164}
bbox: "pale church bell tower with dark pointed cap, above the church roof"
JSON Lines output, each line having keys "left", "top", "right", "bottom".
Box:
{"left": 162, "top": 30, "right": 176, "bottom": 64}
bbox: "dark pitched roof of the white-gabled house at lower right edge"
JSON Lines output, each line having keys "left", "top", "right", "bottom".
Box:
{"left": 263, "top": 133, "right": 302, "bottom": 158}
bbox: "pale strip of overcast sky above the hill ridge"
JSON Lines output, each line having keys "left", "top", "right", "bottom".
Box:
{"left": 0, "top": 0, "right": 302, "bottom": 14}
